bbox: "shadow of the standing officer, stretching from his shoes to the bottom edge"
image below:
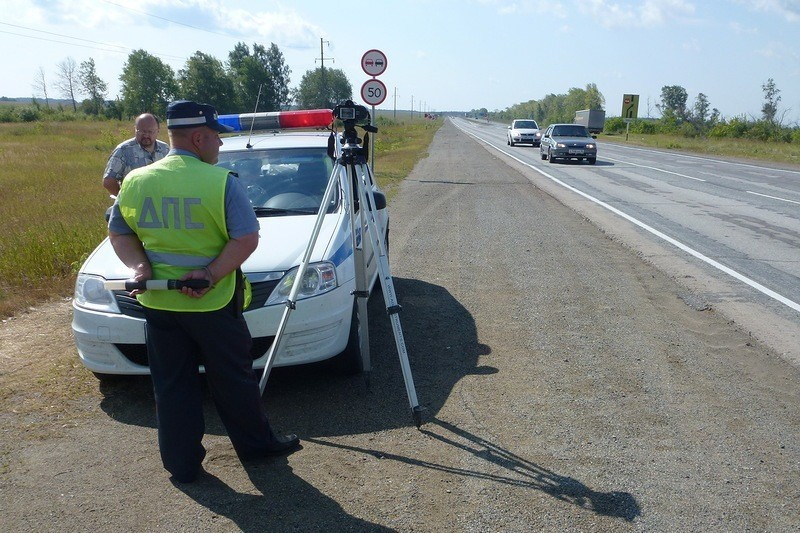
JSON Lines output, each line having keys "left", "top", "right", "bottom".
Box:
{"left": 175, "top": 457, "right": 395, "bottom": 533}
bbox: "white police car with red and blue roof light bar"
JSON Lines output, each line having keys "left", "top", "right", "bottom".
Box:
{"left": 72, "top": 110, "right": 388, "bottom": 379}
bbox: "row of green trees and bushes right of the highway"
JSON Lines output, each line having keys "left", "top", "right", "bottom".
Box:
{"left": 478, "top": 78, "right": 800, "bottom": 143}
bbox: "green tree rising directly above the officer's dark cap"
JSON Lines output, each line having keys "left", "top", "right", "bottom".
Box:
{"left": 178, "top": 51, "right": 234, "bottom": 113}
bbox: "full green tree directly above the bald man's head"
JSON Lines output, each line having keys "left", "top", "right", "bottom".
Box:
{"left": 119, "top": 50, "right": 178, "bottom": 117}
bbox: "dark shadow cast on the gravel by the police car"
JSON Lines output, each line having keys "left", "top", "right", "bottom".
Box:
{"left": 101, "top": 278, "right": 488, "bottom": 437}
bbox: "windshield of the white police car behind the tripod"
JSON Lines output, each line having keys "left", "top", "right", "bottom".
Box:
{"left": 217, "top": 148, "right": 339, "bottom": 216}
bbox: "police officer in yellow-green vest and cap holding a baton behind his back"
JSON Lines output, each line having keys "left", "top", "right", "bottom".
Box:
{"left": 109, "top": 100, "right": 299, "bottom": 483}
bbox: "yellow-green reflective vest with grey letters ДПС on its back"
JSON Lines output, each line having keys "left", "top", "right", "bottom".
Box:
{"left": 118, "top": 155, "right": 236, "bottom": 311}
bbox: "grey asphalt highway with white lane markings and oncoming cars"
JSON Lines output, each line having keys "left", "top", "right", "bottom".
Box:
{"left": 455, "top": 119, "right": 800, "bottom": 364}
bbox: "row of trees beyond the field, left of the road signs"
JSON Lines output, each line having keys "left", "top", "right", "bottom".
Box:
{"left": 0, "top": 42, "right": 353, "bottom": 121}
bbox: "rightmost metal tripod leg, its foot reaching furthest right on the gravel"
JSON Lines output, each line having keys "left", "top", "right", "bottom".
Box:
{"left": 356, "top": 160, "right": 422, "bottom": 427}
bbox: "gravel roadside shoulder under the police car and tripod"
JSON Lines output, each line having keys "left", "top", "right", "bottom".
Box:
{"left": 0, "top": 123, "right": 800, "bottom": 533}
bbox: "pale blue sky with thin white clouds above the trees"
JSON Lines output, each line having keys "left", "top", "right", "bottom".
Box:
{"left": 0, "top": 0, "right": 800, "bottom": 121}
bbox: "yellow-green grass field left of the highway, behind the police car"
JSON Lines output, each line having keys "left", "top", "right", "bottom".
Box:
{"left": 0, "top": 118, "right": 442, "bottom": 318}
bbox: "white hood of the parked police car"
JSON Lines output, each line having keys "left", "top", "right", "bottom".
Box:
{"left": 81, "top": 213, "right": 342, "bottom": 279}
